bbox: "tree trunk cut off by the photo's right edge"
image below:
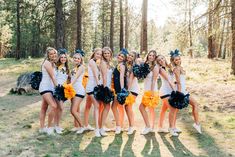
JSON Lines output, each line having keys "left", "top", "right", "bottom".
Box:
{"left": 231, "top": 0, "right": 235, "bottom": 75}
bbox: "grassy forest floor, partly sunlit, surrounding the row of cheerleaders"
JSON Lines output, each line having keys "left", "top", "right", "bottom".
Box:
{"left": 0, "top": 58, "right": 235, "bottom": 157}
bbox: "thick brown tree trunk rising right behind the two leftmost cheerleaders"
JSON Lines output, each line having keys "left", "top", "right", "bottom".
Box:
{"left": 54, "top": 0, "right": 65, "bottom": 49}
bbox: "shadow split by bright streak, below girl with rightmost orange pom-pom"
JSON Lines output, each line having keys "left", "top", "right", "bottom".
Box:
{"left": 141, "top": 133, "right": 161, "bottom": 157}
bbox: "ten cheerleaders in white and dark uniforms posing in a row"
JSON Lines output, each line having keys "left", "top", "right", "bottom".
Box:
{"left": 39, "top": 47, "right": 201, "bottom": 137}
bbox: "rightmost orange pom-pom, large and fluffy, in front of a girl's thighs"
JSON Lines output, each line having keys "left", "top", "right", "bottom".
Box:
{"left": 141, "top": 91, "right": 159, "bottom": 107}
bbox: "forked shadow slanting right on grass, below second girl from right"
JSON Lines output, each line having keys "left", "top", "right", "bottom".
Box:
{"left": 160, "top": 134, "right": 196, "bottom": 157}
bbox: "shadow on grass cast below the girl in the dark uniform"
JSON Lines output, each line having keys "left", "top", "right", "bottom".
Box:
{"left": 103, "top": 133, "right": 123, "bottom": 157}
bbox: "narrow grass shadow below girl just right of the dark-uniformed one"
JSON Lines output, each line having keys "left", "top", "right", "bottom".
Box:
{"left": 122, "top": 131, "right": 136, "bottom": 157}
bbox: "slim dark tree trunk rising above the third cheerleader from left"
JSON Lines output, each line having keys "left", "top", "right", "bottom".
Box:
{"left": 76, "top": 0, "right": 82, "bottom": 49}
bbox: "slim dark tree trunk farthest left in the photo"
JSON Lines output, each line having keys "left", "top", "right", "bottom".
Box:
{"left": 15, "top": 0, "right": 21, "bottom": 60}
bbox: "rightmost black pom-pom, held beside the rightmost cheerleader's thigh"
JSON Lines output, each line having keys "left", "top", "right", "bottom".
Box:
{"left": 168, "top": 91, "right": 189, "bottom": 109}
